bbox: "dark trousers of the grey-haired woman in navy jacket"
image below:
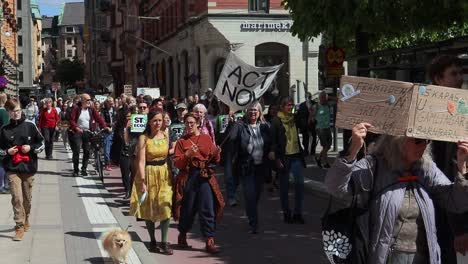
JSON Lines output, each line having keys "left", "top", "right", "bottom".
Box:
{"left": 240, "top": 164, "right": 267, "bottom": 230}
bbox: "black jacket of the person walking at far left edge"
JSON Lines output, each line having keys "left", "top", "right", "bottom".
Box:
{"left": 0, "top": 117, "right": 44, "bottom": 174}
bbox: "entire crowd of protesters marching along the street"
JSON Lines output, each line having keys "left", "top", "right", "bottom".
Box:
{"left": 0, "top": 56, "right": 468, "bottom": 263}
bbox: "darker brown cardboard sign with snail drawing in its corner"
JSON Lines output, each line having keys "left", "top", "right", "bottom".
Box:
{"left": 336, "top": 76, "right": 413, "bottom": 136}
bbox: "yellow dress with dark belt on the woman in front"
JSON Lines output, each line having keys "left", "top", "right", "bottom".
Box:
{"left": 130, "top": 136, "right": 172, "bottom": 222}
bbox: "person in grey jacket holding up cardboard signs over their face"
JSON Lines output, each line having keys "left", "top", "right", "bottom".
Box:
{"left": 325, "top": 123, "right": 468, "bottom": 264}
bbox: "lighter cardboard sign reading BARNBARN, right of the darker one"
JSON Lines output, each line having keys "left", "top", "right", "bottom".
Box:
{"left": 407, "top": 85, "right": 468, "bottom": 142}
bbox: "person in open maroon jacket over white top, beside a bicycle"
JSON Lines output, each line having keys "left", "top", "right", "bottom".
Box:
{"left": 68, "top": 94, "right": 112, "bottom": 177}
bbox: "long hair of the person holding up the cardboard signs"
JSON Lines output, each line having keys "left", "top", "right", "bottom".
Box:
{"left": 371, "top": 135, "right": 433, "bottom": 171}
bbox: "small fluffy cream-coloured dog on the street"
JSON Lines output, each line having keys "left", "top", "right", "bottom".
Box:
{"left": 101, "top": 230, "right": 132, "bottom": 264}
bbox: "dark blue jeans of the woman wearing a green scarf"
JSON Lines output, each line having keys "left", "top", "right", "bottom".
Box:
{"left": 279, "top": 157, "right": 304, "bottom": 214}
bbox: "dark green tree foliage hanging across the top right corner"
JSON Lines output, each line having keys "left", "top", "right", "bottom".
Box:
{"left": 283, "top": 0, "right": 468, "bottom": 53}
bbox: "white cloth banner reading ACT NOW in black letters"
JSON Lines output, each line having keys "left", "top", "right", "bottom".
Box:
{"left": 214, "top": 52, "right": 283, "bottom": 111}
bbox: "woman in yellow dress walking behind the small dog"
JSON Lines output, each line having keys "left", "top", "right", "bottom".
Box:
{"left": 130, "top": 112, "right": 173, "bottom": 255}
